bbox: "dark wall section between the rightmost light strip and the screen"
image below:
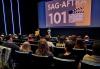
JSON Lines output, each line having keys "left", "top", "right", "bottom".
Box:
{"left": 20, "top": 0, "right": 38, "bottom": 34}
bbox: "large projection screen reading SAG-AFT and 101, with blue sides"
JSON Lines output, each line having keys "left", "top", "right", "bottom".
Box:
{"left": 38, "top": 0, "right": 100, "bottom": 28}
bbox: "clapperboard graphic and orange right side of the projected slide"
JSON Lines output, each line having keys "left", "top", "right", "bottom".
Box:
{"left": 68, "top": 0, "right": 91, "bottom": 26}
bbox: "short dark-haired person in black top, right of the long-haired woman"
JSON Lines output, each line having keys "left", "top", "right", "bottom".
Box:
{"left": 58, "top": 42, "right": 74, "bottom": 59}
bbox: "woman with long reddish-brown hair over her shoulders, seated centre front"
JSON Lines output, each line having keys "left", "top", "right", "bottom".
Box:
{"left": 35, "top": 38, "right": 53, "bottom": 56}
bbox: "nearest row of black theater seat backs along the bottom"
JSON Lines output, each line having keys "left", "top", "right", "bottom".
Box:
{"left": 13, "top": 51, "right": 100, "bottom": 69}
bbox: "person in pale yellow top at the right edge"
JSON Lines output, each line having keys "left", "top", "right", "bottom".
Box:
{"left": 83, "top": 42, "right": 100, "bottom": 64}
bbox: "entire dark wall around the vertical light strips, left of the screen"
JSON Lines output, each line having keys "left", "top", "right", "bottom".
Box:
{"left": 0, "top": 0, "right": 38, "bottom": 34}
